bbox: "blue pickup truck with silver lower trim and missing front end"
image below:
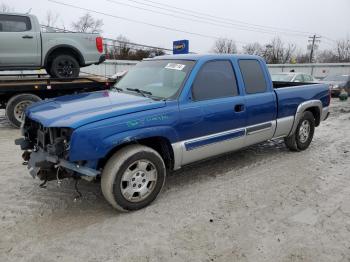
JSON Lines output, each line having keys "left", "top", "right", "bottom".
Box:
{"left": 16, "top": 55, "right": 330, "bottom": 211}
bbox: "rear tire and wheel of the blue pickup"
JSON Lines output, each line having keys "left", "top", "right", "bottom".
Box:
{"left": 284, "top": 111, "right": 315, "bottom": 151}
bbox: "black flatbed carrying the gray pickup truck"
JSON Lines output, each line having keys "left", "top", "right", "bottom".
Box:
{"left": 0, "top": 75, "right": 116, "bottom": 128}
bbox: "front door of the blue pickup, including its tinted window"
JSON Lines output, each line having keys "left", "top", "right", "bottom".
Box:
{"left": 178, "top": 60, "right": 246, "bottom": 165}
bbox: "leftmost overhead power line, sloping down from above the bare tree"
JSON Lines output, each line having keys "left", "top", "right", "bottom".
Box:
{"left": 47, "top": 0, "right": 246, "bottom": 44}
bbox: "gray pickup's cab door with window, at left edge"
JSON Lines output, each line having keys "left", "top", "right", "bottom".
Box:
{"left": 0, "top": 14, "right": 41, "bottom": 68}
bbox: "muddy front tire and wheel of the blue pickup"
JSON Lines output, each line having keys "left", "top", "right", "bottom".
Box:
{"left": 101, "top": 145, "right": 166, "bottom": 211}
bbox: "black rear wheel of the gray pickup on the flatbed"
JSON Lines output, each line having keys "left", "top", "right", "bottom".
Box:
{"left": 48, "top": 54, "right": 80, "bottom": 78}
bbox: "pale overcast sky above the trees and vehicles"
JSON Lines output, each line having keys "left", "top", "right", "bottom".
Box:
{"left": 0, "top": 0, "right": 350, "bottom": 52}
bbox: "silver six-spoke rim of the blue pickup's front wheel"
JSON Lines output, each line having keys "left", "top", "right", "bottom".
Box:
{"left": 120, "top": 159, "right": 158, "bottom": 202}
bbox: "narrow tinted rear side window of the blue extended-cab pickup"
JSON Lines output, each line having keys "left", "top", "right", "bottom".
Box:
{"left": 239, "top": 60, "right": 267, "bottom": 94}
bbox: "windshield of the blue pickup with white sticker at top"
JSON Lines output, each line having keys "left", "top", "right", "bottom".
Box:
{"left": 114, "top": 60, "right": 195, "bottom": 99}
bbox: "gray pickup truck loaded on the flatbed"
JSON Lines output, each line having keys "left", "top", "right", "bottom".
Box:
{"left": 0, "top": 13, "right": 105, "bottom": 78}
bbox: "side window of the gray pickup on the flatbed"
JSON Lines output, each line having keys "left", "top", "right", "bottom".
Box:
{"left": 0, "top": 15, "right": 32, "bottom": 32}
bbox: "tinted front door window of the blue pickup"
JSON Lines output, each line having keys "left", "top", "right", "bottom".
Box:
{"left": 192, "top": 61, "right": 238, "bottom": 101}
